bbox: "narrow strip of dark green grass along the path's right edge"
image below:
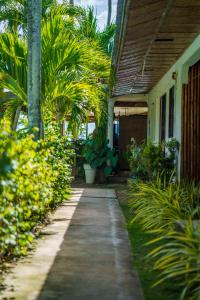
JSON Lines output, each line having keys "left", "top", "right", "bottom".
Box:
{"left": 121, "top": 201, "right": 179, "bottom": 300}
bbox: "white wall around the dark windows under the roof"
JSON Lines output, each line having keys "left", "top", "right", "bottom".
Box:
{"left": 148, "top": 34, "right": 200, "bottom": 143}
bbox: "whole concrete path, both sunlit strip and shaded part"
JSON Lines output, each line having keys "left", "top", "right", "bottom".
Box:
{"left": 0, "top": 188, "right": 142, "bottom": 300}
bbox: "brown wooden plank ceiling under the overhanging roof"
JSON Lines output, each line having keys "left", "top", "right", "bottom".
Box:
{"left": 113, "top": 0, "right": 200, "bottom": 96}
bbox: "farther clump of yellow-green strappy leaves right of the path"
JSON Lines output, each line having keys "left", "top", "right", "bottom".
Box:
{"left": 129, "top": 178, "right": 200, "bottom": 230}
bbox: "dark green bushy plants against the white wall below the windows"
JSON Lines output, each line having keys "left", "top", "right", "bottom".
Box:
{"left": 129, "top": 139, "right": 178, "bottom": 180}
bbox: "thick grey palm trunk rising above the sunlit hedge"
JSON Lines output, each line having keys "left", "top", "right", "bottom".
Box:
{"left": 27, "top": 0, "right": 42, "bottom": 140}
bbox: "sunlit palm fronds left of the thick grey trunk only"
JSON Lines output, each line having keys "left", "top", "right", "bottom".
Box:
{"left": 0, "top": 33, "right": 27, "bottom": 126}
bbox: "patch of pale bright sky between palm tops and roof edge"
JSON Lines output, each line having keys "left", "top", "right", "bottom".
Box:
{"left": 74, "top": 0, "right": 117, "bottom": 29}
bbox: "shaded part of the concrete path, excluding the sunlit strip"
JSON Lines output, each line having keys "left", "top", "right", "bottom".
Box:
{"left": 37, "top": 189, "right": 142, "bottom": 300}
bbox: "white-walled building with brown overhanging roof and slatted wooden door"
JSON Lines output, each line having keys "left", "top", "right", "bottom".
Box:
{"left": 108, "top": 0, "right": 200, "bottom": 181}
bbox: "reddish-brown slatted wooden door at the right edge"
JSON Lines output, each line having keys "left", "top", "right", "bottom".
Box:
{"left": 181, "top": 61, "right": 200, "bottom": 182}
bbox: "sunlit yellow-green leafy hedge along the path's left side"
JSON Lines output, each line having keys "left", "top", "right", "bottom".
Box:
{"left": 0, "top": 124, "right": 71, "bottom": 258}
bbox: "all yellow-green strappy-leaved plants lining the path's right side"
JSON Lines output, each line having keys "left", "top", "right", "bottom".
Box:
{"left": 129, "top": 178, "right": 200, "bottom": 299}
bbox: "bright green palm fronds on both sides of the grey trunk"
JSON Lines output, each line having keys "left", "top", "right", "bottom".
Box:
{"left": 0, "top": 7, "right": 110, "bottom": 135}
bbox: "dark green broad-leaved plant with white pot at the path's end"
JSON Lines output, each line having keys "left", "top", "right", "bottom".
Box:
{"left": 83, "top": 136, "right": 118, "bottom": 184}
